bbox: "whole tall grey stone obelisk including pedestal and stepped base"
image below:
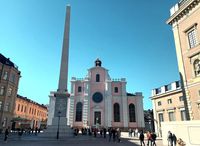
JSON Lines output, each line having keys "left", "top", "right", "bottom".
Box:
{"left": 41, "top": 5, "right": 72, "bottom": 138}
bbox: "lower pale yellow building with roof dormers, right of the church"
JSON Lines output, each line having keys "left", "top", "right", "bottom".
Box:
{"left": 151, "top": 81, "right": 187, "bottom": 136}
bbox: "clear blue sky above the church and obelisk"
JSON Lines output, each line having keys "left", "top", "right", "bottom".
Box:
{"left": 0, "top": 0, "right": 179, "bottom": 109}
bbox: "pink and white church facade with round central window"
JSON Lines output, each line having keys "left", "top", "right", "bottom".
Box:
{"left": 68, "top": 59, "right": 144, "bottom": 128}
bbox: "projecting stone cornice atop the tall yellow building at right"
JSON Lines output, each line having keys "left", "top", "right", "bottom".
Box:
{"left": 166, "top": 0, "right": 200, "bottom": 25}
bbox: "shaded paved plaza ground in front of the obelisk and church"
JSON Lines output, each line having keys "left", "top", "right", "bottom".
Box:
{"left": 0, "top": 133, "right": 163, "bottom": 146}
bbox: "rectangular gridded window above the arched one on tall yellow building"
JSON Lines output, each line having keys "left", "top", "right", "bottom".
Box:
{"left": 187, "top": 27, "right": 198, "bottom": 48}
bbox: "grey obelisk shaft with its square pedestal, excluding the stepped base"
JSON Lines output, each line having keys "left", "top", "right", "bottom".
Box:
{"left": 54, "top": 5, "right": 70, "bottom": 120}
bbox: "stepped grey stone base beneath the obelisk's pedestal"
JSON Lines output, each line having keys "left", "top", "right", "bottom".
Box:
{"left": 39, "top": 117, "right": 73, "bottom": 138}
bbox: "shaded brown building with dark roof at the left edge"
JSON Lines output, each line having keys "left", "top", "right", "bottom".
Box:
{"left": 0, "top": 54, "right": 20, "bottom": 132}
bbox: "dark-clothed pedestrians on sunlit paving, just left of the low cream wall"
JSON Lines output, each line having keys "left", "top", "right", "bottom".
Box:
{"left": 139, "top": 131, "right": 157, "bottom": 146}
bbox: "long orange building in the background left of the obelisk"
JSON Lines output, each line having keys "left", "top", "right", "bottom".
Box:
{"left": 12, "top": 95, "right": 47, "bottom": 129}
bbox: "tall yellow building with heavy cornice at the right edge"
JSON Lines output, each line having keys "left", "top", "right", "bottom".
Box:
{"left": 167, "top": 0, "right": 200, "bottom": 120}
